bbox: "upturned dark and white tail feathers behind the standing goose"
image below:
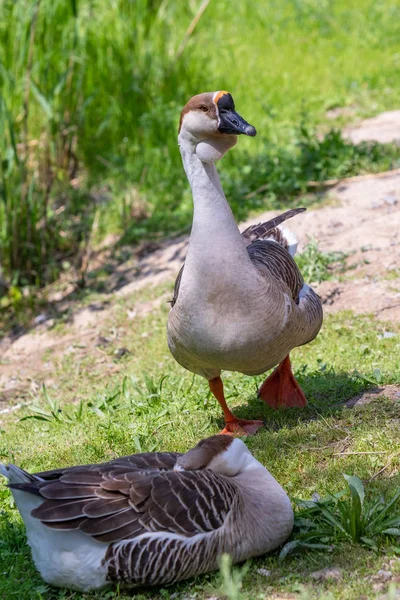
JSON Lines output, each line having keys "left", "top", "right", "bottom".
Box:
{"left": 242, "top": 208, "right": 307, "bottom": 256}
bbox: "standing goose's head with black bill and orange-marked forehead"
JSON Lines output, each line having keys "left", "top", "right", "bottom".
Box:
{"left": 178, "top": 90, "right": 257, "bottom": 163}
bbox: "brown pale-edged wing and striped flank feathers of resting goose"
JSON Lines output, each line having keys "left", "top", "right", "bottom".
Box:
{"left": 18, "top": 450, "right": 241, "bottom": 585}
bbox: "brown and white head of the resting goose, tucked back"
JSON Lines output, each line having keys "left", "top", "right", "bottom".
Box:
{"left": 174, "top": 435, "right": 261, "bottom": 477}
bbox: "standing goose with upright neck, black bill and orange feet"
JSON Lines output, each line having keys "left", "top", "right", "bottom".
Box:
{"left": 168, "top": 91, "right": 322, "bottom": 434}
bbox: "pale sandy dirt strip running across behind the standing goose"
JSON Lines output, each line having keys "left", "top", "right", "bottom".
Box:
{"left": 0, "top": 111, "right": 400, "bottom": 406}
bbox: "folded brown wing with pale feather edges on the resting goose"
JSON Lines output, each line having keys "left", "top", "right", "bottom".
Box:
{"left": 15, "top": 460, "right": 238, "bottom": 543}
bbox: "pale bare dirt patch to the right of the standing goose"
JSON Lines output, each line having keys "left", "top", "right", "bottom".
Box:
{"left": 244, "top": 172, "right": 400, "bottom": 321}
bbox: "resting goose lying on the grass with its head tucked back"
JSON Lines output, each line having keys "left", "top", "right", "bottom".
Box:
{"left": 0, "top": 435, "right": 293, "bottom": 591}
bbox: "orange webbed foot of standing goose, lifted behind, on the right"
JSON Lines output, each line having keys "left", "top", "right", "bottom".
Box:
{"left": 258, "top": 355, "right": 307, "bottom": 408}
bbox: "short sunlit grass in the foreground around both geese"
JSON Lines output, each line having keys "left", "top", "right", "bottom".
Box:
{"left": 0, "top": 276, "right": 400, "bottom": 600}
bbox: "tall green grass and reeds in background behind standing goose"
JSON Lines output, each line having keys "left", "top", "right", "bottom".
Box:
{"left": 0, "top": 0, "right": 400, "bottom": 286}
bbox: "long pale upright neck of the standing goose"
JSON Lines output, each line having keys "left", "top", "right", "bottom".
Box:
{"left": 179, "top": 136, "right": 249, "bottom": 267}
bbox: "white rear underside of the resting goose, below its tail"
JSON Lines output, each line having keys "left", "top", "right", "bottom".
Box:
{"left": 13, "top": 490, "right": 109, "bottom": 591}
